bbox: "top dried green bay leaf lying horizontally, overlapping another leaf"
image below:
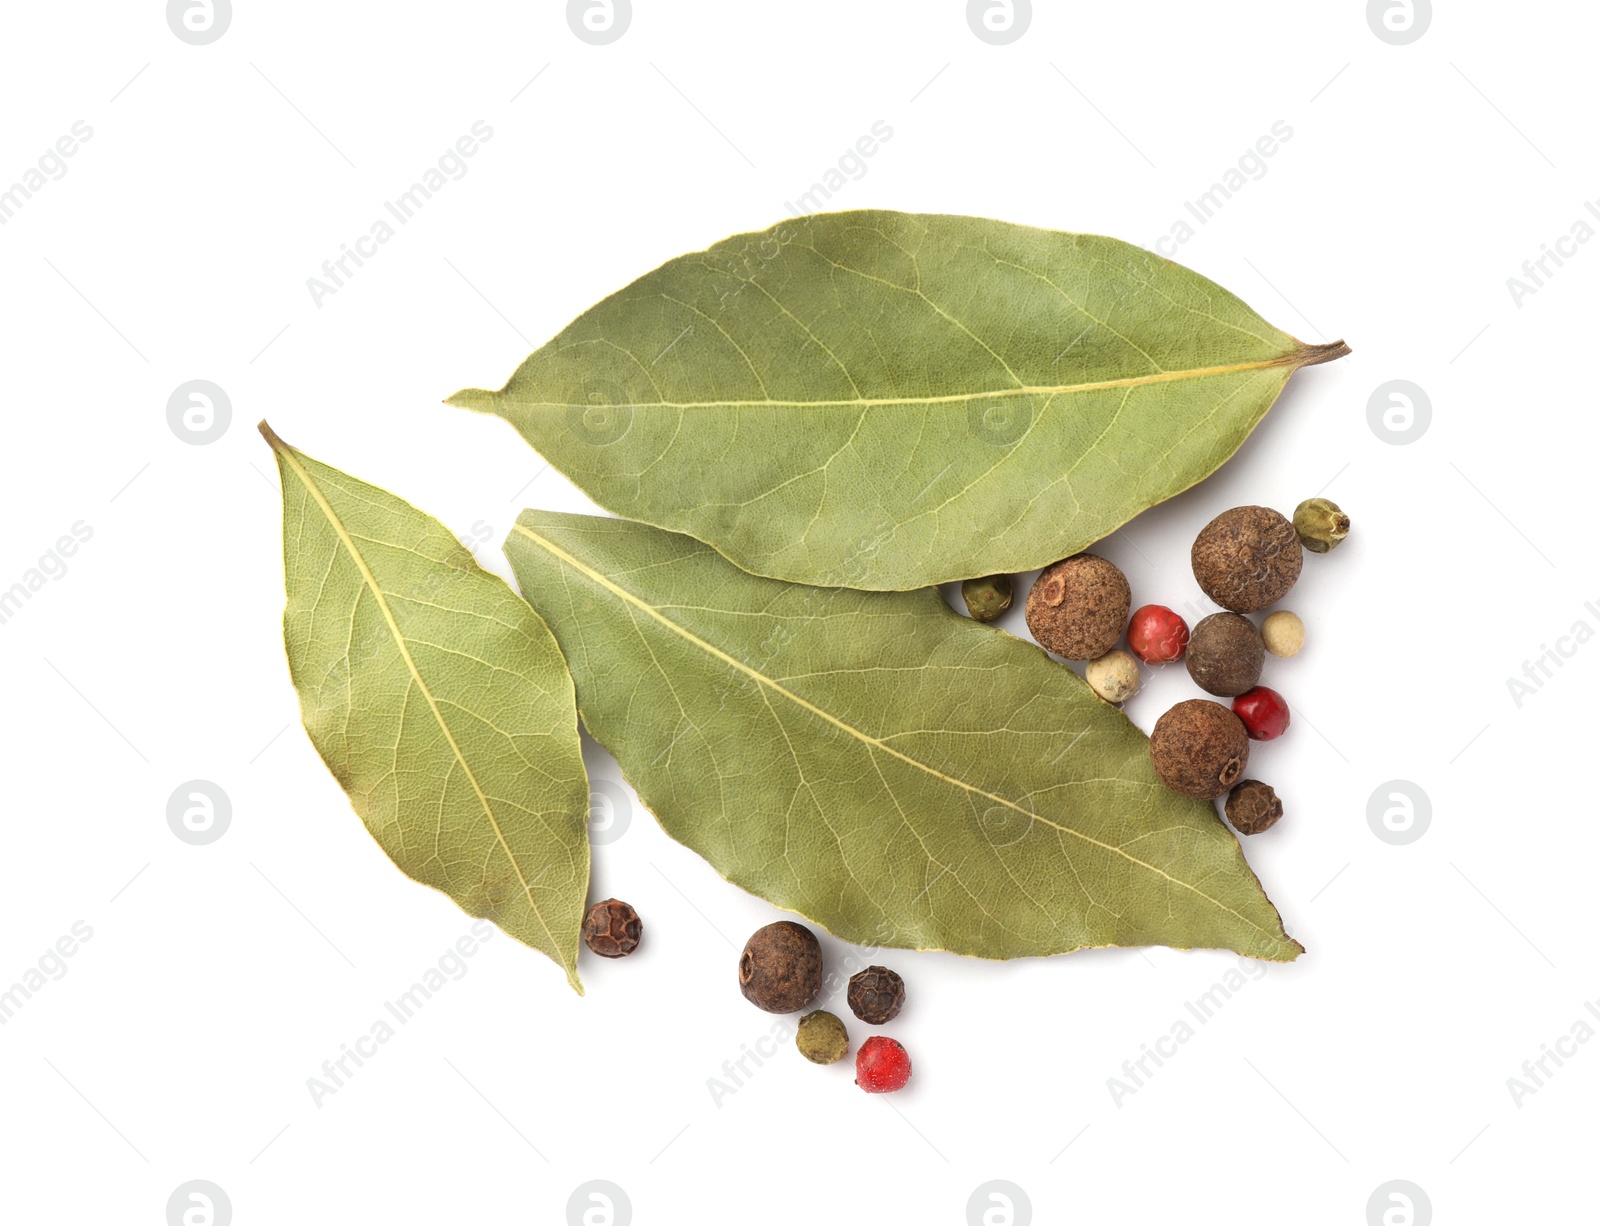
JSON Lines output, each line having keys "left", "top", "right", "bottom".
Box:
{"left": 448, "top": 211, "right": 1349, "bottom": 589}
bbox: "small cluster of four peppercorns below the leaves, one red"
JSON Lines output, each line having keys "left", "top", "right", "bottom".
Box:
{"left": 739, "top": 920, "right": 910, "bottom": 1095}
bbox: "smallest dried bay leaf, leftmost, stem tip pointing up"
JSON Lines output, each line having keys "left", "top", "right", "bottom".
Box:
{"left": 261, "top": 423, "right": 589, "bottom": 994}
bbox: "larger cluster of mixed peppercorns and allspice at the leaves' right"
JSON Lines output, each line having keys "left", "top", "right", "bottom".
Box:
{"left": 962, "top": 498, "right": 1350, "bottom": 834}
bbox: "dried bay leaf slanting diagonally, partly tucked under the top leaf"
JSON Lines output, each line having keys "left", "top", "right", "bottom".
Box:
{"left": 506, "top": 511, "right": 1301, "bottom": 960}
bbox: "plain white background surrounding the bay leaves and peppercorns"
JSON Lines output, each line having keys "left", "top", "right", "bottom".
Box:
{"left": 0, "top": 0, "right": 1600, "bottom": 1226}
